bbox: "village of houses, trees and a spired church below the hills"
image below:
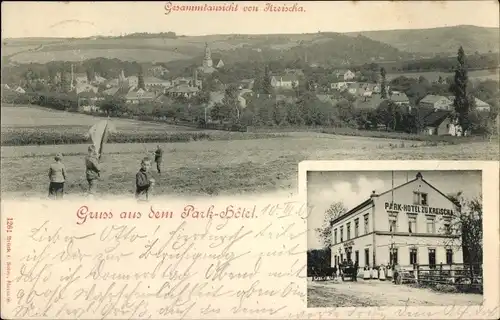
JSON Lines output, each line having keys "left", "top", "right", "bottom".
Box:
{"left": 2, "top": 43, "right": 498, "bottom": 136}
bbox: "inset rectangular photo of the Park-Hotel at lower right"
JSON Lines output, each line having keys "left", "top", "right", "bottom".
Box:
{"left": 307, "top": 170, "right": 484, "bottom": 308}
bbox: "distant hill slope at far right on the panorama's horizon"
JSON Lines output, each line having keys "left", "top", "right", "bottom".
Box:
{"left": 347, "top": 25, "right": 500, "bottom": 54}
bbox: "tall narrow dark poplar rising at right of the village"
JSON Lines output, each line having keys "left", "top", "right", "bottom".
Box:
{"left": 450, "top": 46, "right": 470, "bottom": 132}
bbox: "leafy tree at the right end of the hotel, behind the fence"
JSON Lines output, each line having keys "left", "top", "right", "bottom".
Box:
{"left": 445, "top": 192, "right": 483, "bottom": 284}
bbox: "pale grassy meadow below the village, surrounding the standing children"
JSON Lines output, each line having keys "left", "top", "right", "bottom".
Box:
{"left": 1, "top": 107, "right": 499, "bottom": 198}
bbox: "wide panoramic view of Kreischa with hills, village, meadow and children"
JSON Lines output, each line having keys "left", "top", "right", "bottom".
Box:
{"left": 1, "top": 1, "right": 499, "bottom": 200}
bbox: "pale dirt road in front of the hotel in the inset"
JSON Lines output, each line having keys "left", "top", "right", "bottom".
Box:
{"left": 307, "top": 279, "right": 483, "bottom": 308}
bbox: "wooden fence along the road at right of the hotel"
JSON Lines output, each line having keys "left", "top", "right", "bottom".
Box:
{"left": 397, "top": 263, "right": 483, "bottom": 291}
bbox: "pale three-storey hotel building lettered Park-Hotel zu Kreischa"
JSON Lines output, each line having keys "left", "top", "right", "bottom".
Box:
{"left": 331, "top": 173, "right": 463, "bottom": 269}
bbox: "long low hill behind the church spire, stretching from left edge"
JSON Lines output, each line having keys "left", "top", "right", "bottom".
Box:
{"left": 2, "top": 33, "right": 410, "bottom": 64}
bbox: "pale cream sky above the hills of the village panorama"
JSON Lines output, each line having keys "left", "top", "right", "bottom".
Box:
{"left": 2, "top": 0, "right": 499, "bottom": 38}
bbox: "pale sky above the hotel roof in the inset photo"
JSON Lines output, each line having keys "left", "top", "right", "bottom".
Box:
{"left": 307, "top": 171, "right": 482, "bottom": 249}
